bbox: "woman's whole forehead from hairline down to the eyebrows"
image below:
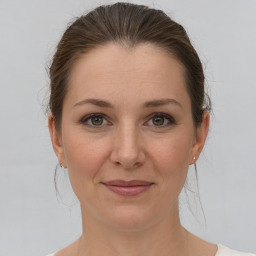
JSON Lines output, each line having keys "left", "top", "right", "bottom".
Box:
{"left": 67, "top": 43, "right": 189, "bottom": 109}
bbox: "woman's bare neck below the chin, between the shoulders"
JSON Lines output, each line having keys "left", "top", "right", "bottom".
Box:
{"left": 77, "top": 204, "right": 188, "bottom": 256}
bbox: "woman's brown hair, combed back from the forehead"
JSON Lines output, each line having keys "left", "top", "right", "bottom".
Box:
{"left": 49, "top": 3, "right": 211, "bottom": 131}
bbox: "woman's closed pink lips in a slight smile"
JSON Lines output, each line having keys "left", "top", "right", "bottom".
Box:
{"left": 102, "top": 180, "right": 154, "bottom": 196}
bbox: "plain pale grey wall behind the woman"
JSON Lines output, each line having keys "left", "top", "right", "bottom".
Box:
{"left": 0, "top": 0, "right": 256, "bottom": 256}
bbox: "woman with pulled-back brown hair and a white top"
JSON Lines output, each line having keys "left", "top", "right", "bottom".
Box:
{"left": 45, "top": 3, "right": 252, "bottom": 256}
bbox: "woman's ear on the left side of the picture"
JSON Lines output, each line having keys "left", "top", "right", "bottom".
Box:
{"left": 48, "top": 114, "right": 66, "bottom": 167}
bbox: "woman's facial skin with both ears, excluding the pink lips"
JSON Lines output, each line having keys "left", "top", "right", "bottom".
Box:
{"left": 49, "top": 44, "right": 208, "bottom": 229}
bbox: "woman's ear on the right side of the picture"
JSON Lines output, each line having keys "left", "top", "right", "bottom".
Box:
{"left": 190, "top": 111, "right": 210, "bottom": 164}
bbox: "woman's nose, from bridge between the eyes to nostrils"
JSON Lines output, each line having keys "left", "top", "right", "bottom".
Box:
{"left": 110, "top": 122, "right": 145, "bottom": 169}
